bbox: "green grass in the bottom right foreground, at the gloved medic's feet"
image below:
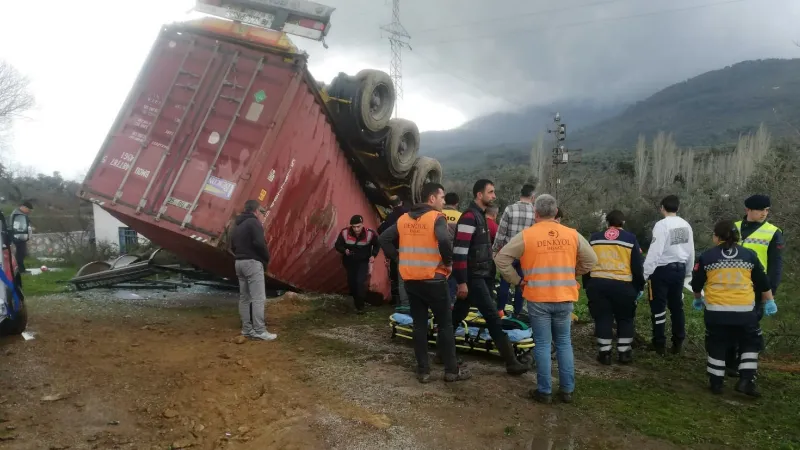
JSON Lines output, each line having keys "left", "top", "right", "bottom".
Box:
{"left": 576, "top": 368, "right": 800, "bottom": 449}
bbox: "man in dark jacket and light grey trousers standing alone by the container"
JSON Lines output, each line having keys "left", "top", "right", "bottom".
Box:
{"left": 231, "top": 200, "right": 278, "bottom": 341}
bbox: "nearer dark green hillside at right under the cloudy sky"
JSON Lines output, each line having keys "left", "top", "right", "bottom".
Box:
{"left": 572, "top": 59, "right": 800, "bottom": 150}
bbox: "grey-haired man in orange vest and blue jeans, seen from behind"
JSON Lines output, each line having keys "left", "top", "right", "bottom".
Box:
{"left": 495, "top": 194, "right": 597, "bottom": 403}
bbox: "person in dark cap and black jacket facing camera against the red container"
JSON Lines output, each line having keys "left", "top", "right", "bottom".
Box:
{"left": 334, "top": 214, "right": 380, "bottom": 314}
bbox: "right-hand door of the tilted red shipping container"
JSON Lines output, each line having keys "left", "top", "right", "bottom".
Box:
{"left": 148, "top": 43, "right": 295, "bottom": 236}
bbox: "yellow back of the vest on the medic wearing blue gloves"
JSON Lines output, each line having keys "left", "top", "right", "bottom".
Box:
{"left": 704, "top": 258, "right": 755, "bottom": 312}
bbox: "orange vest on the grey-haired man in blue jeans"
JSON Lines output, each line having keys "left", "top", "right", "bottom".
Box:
{"left": 520, "top": 222, "right": 578, "bottom": 302}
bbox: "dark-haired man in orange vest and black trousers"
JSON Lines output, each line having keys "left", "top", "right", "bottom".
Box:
{"left": 378, "top": 183, "right": 470, "bottom": 383}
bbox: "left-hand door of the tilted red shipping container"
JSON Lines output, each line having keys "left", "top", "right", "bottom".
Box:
{"left": 86, "top": 33, "right": 222, "bottom": 212}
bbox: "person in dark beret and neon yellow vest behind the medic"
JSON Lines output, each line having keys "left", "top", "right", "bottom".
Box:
{"left": 725, "top": 194, "right": 785, "bottom": 378}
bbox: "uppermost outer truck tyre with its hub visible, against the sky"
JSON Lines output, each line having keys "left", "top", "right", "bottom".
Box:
{"left": 353, "top": 69, "right": 396, "bottom": 132}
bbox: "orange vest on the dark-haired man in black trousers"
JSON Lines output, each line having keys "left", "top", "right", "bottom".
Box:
{"left": 397, "top": 211, "right": 450, "bottom": 281}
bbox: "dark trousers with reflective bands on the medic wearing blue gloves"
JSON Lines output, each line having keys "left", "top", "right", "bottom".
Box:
{"left": 706, "top": 319, "right": 764, "bottom": 385}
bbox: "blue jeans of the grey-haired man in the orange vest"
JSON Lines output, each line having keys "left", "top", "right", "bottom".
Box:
{"left": 528, "top": 302, "right": 575, "bottom": 394}
